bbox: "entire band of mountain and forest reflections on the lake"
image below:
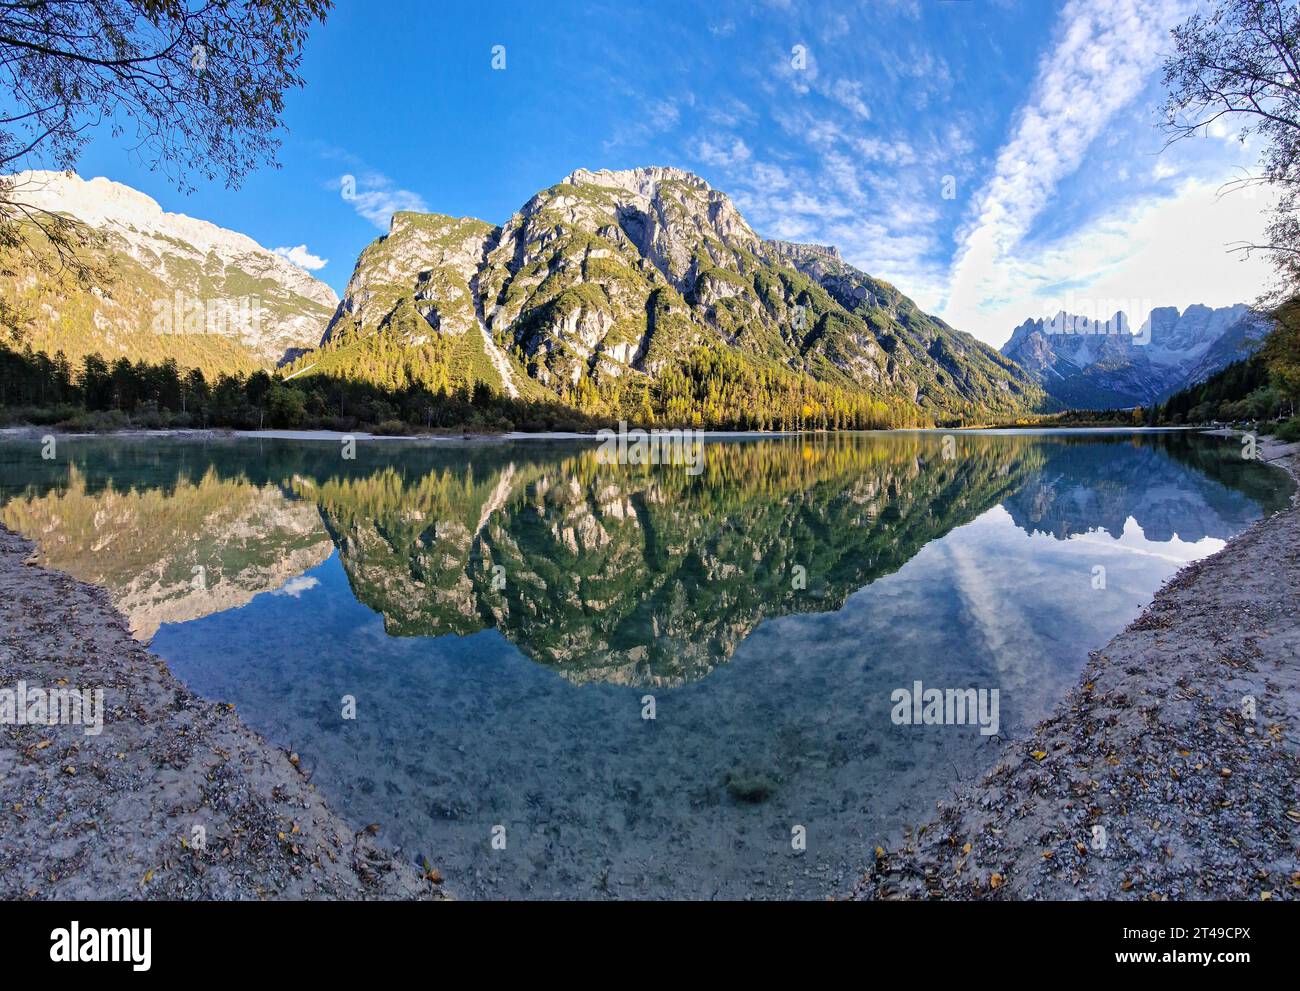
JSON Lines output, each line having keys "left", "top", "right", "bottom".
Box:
{"left": 20, "top": 433, "right": 1291, "bottom": 687}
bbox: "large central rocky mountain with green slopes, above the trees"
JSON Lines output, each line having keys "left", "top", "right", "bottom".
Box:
{"left": 295, "top": 168, "right": 1041, "bottom": 417}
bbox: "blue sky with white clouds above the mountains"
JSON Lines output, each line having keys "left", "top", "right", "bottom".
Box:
{"left": 65, "top": 0, "right": 1269, "bottom": 345}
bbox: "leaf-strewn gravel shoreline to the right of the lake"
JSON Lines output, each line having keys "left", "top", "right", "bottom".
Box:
{"left": 852, "top": 442, "right": 1300, "bottom": 900}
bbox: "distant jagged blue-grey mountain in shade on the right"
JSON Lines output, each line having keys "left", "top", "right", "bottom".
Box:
{"left": 1002, "top": 303, "right": 1270, "bottom": 410}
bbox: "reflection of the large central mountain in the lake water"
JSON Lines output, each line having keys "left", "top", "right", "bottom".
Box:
{"left": 304, "top": 434, "right": 1039, "bottom": 687}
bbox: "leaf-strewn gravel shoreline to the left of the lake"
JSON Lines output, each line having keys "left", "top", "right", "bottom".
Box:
{"left": 0, "top": 527, "right": 441, "bottom": 900}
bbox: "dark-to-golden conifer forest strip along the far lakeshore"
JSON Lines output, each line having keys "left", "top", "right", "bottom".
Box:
{"left": 0, "top": 334, "right": 928, "bottom": 430}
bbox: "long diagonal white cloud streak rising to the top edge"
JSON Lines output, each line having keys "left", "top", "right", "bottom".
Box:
{"left": 944, "top": 0, "right": 1187, "bottom": 337}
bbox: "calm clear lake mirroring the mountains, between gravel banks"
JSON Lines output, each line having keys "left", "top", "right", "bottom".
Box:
{"left": 0, "top": 432, "right": 1292, "bottom": 899}
